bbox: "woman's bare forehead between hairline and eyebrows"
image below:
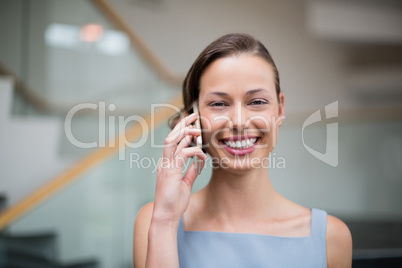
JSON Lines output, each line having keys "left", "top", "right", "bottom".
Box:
{"left": 200, "top": 54, "right": 275, "bottom": 97}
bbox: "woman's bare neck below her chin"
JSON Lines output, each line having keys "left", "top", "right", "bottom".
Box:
{"left": 204, "top": 168, "right": 279, "bottom": 222}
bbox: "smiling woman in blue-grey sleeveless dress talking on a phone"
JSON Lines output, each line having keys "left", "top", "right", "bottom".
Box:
{"left": 134, "top": 34, "right": 352, "bottom": 268}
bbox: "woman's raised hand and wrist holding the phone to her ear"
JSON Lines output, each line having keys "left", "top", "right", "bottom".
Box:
{"left": 152, "top": 114, "right": 207, "bottom": 226}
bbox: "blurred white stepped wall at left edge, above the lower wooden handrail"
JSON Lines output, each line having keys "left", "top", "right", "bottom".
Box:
{"left": 0, "top": 77, "right": 72, "bottom": 206}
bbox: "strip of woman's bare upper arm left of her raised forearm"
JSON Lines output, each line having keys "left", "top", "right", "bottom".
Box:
{"left": 133, "top": 202, "right": 154, "bottom": 268}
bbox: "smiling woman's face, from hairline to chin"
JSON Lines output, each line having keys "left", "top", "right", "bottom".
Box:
{"left": 199, "top": 54, "right": 284, "bottom": 171}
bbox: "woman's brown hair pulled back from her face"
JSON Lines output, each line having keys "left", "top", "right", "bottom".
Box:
{"left": 169, "top": 33, "right": 281, "bottom": 128}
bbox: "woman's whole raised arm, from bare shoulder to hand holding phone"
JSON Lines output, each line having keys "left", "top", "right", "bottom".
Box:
{"left": 134, "top": 114, "right": 207, "bottom": 268}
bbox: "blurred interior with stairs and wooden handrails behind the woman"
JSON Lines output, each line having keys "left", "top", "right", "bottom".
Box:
{"left": 0, "top": 0, "right": 402, "bottom": 268}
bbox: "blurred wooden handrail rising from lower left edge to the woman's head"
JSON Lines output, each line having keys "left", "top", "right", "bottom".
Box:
{"left": 0, "top": 94, "right": 182, "bottom": 230}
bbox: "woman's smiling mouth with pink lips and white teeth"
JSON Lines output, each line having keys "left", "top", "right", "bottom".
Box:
{"left": 219, "top": 136, "right": 260, "bottom": 155}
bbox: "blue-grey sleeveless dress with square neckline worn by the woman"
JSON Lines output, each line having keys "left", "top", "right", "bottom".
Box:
{"left": 177, "top": 208, "right": 327, "bottom": 268}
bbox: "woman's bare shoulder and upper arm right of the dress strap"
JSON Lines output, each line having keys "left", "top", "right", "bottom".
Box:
{"left": 326, "top": 215, "right": 352, "bottom": 268}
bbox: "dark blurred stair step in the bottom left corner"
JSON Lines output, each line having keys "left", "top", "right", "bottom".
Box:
{"left": 0, "top": 233, "right": 57, "bottom": 261}
